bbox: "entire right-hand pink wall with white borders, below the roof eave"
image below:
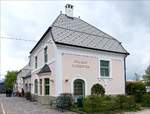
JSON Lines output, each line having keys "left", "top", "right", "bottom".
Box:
{"left": 57, "top": 45, "right": 125, "bottom": 95}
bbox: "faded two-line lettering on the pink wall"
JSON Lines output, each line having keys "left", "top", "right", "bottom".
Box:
{"left": 72, "top": 60, "right": 90, "bottom": 68}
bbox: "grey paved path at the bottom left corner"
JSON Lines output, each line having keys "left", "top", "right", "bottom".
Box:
{"left": 0, "top": 95, "right": 76, "bottom": 114}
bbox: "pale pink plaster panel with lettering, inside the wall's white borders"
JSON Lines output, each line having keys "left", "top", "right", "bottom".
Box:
{"left": 62, "top": 54, "right": 125, "bottom": 95}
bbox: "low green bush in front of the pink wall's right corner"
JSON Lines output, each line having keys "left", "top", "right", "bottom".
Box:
{"left": 114, "top": 95, "right": 139, "bottom": 110}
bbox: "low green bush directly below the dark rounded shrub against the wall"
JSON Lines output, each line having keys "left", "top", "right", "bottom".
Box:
{"left": 83, "top": 95, "right": 113, "bottom": 113}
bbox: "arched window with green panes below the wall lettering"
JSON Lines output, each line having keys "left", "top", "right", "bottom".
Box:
{"left": 73, "top": 79, "right": 85, "bottom": 96}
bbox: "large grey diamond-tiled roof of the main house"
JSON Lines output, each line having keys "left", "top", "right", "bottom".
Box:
{"left": 30, "top": 14, "right": 129, "bottom": 54}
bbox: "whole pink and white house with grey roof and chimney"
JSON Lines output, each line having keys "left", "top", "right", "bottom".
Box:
{"left": 17, "top": 4, "right": 129, "bottom": 104}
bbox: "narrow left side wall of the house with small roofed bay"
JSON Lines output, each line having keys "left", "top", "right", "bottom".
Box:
{"left": 30, "top": 32, "right": 56, "bottom": 96}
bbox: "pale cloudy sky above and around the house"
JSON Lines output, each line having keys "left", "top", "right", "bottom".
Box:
{"left": 0, "top": 0, "right": 150, "bottom": 80}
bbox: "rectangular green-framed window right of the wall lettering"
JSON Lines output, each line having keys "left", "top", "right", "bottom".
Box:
{"left": 100, "top": 60, "right": 109, "bottom": 77}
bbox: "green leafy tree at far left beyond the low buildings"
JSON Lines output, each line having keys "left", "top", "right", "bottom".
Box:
{"left": 4, "top": 71, "right": 17, "bottom": 89}
